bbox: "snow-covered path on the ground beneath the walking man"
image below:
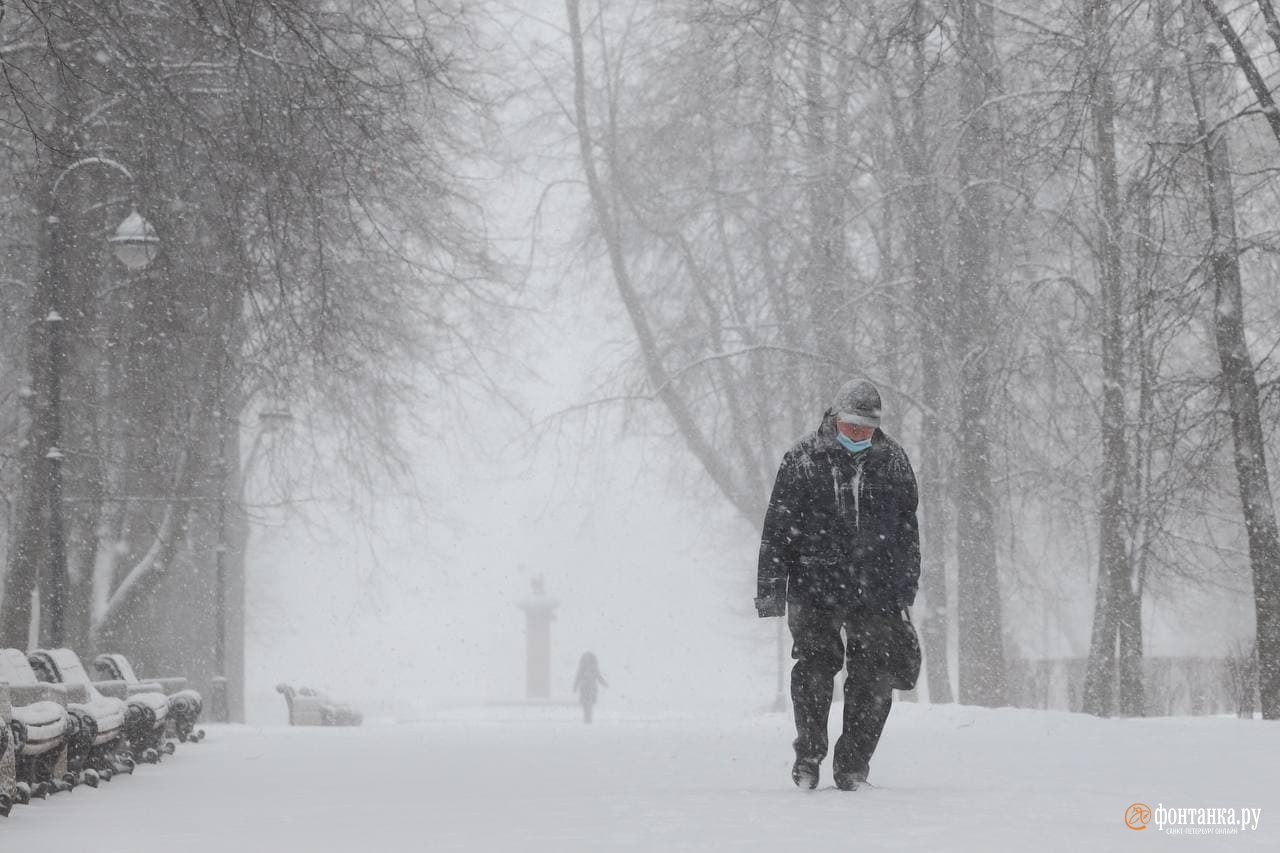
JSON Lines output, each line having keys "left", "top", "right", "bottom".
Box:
{"left": 0, "top": 704, "right": 1280, "bottom": 853}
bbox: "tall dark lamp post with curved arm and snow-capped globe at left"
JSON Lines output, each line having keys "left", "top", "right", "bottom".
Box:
{"left": 40, "top": 158, "right": 160, "bottom": 647}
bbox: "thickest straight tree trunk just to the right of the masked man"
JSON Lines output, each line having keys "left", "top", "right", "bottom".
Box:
{"left": 955, "top": 0, "right": 1006, "bottom": 706}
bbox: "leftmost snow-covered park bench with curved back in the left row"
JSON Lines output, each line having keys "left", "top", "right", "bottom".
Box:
{"left": 0, "top": 648, "right": 74, "bottom": 803}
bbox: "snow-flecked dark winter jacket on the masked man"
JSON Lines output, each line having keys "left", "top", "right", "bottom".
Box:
{"left": 756, "top": 412, "right": 920, "bottom": 615}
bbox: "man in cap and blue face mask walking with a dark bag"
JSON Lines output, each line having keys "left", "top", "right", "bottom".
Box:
{"left": 755, "top": 379, "right": 920, "bottom": 790}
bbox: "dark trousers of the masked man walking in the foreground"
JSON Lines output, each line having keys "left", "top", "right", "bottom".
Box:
{"left": 787, "top": 605, "right": 893, "bottom": 777}
